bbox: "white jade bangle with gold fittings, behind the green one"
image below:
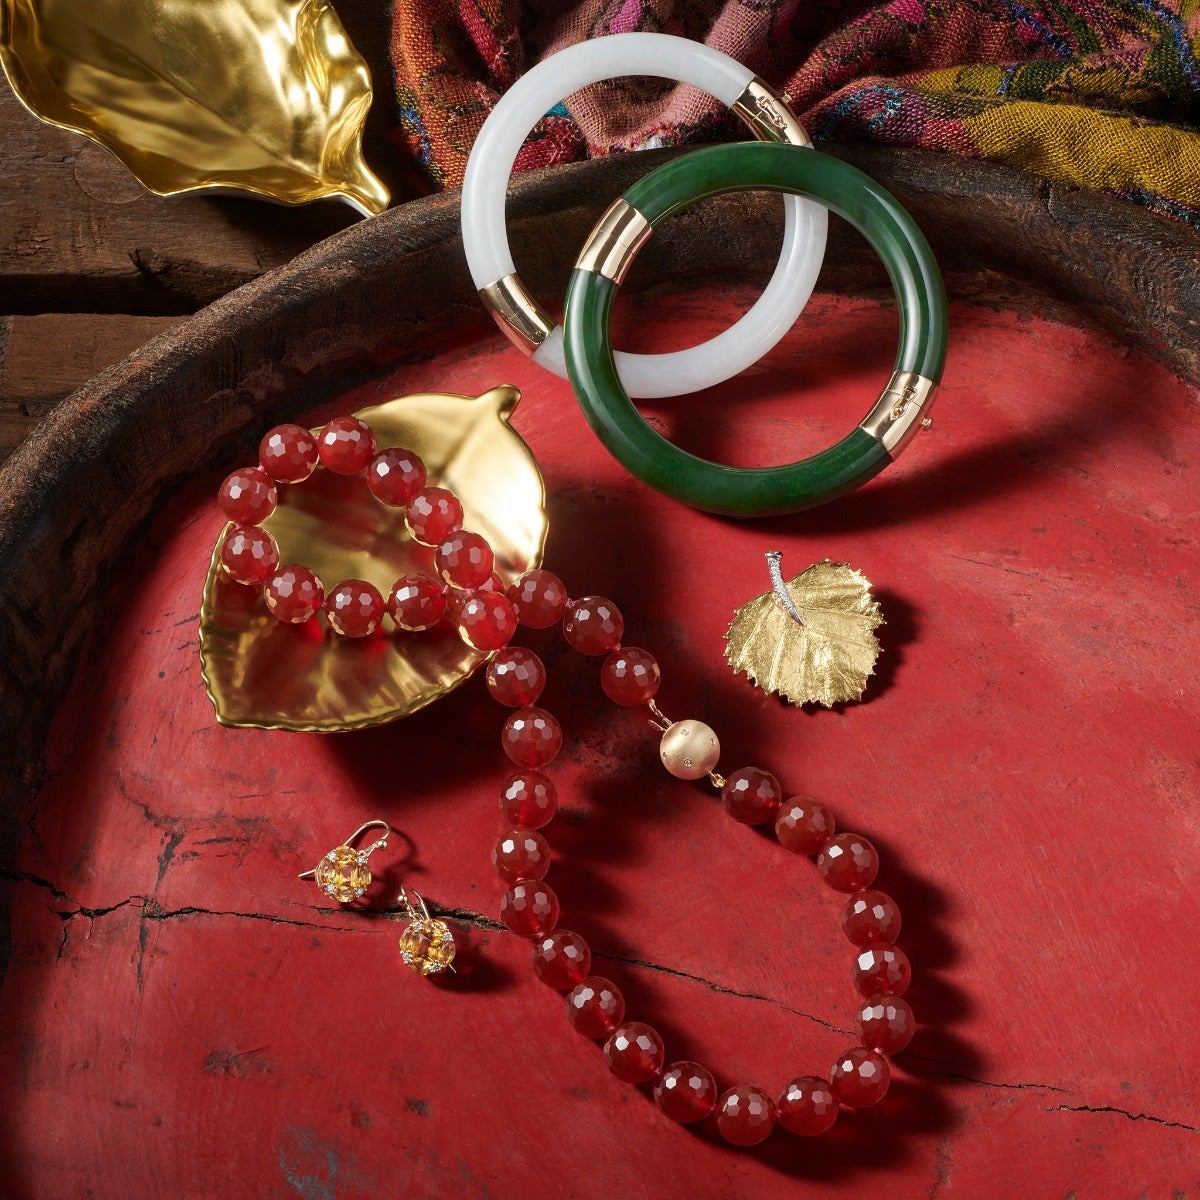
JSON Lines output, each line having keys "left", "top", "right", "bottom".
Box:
{"left": 462, "top": 34, "right": 829, "bottom": 397}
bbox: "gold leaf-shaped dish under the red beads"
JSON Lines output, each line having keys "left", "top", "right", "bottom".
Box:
{"left": 200, "top": 386, "right": 546, "bottom": 732}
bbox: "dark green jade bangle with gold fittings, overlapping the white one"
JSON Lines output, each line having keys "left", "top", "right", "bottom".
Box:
{"left": 563, "top": 143, "right": 946, "bottom": 516}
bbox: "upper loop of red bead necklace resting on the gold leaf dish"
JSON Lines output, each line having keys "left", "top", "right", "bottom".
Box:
{"left": 217, "top": 416, "right": 520, "bottom": 652}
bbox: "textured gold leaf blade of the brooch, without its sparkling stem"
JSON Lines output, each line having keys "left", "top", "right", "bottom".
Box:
{"left": 725, "top": 559, "right": 883, "bottom": 708}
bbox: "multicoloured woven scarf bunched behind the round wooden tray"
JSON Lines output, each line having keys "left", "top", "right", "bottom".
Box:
{"left": 391, "top": 0, "right": 1200, "bottom": 227}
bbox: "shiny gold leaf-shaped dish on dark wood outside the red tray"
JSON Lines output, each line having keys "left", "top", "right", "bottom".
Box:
{"left": 0, "top": 0, "right": 389, "bottom": 216}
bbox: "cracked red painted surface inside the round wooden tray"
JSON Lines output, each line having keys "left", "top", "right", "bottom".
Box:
{"left": 0, "top": 290, "right": 1200, "bottom": 1198}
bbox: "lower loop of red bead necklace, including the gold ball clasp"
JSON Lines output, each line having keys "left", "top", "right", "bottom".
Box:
{"left": 487, "top": 571, "right": 916, "bottom": 1146}
